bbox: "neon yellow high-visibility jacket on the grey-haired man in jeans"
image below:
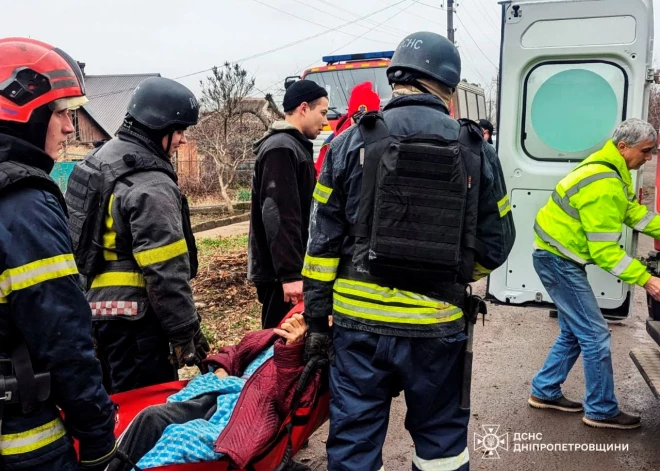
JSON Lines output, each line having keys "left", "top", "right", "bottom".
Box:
{"left": 534, "top": 141, "right": 660, "bottom": 286}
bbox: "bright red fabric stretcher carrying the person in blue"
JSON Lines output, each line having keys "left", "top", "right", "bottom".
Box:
{"left": 111, "top": 303, "right": 330, "bottom": 471}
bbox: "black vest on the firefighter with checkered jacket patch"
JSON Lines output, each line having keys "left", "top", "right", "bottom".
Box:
{"left": 65, "top": 140, "right": 198, "bottom": 279}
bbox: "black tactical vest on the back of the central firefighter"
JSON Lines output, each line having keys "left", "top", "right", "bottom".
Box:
{"left": 349, "top": 113, "right": 483, "bottom": 304}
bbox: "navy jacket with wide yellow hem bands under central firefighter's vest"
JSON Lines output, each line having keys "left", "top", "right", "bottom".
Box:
{"left": 303, "top": 94, "right": 515, "bottom": 337}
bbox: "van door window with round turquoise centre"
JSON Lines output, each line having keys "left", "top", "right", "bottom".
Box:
{"left": 521, "top": 61, "right": 628, "bottom": 161}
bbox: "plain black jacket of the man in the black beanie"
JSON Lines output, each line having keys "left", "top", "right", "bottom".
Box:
{"left": 248, "top": 121, "right": 316, "bottom": 283}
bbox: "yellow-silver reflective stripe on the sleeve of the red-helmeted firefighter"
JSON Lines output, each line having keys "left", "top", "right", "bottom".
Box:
{"left": 0, "top": 253, "right": 78, "bottom": 297}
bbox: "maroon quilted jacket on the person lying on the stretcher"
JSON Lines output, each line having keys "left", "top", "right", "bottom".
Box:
{"left": 204, "top": 329, "right": 321, "bottom": 469}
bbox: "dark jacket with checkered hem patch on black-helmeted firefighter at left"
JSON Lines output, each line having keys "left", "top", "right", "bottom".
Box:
{"left": 79, "top": 131, "right": 198, "bottom": 335}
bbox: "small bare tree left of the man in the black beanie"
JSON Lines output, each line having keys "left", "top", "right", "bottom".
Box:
{"left": 191, "top": 62, "right": 272, "bottom": 214}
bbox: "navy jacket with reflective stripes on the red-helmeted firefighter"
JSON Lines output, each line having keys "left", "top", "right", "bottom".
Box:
{"left": 0, "top": 134, "right": 115, "bottom": 470}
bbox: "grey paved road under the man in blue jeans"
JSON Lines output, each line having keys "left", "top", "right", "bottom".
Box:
{"left": 299, "top": 162, "right": 660, "bottom": 471}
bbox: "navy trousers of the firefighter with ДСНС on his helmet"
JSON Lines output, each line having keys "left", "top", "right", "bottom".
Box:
{"left": 327, "top": 325, "right": 470, "bottom": 471}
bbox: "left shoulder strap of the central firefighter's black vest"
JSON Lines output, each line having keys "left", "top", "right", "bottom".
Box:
{"left": 348, "top": 112, "right": 392, "bottom": 238}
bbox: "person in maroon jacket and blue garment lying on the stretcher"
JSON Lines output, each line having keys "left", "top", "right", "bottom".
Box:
{"left": 108, "top": 314, "right": 320, "bottom": 471}
